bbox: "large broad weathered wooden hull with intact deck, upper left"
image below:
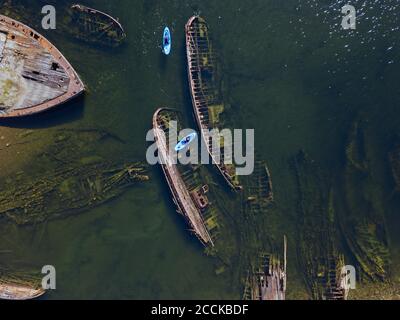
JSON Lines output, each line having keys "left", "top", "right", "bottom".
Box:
{"left": 0, "top": 15, "right": 85, "bottom": 117}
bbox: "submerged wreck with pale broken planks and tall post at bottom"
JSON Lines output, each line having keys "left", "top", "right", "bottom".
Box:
{"left": 240, "top": 160, "right": 287, "bottom": 300}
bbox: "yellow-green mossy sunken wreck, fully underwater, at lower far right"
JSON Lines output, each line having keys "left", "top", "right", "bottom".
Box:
{"left": 339, "top": 121, "right": 390, "bottom": 281}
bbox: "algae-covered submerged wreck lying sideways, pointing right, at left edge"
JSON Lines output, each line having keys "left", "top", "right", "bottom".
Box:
{"left": 0, "top": 162, "right": 148, "bottom": 225}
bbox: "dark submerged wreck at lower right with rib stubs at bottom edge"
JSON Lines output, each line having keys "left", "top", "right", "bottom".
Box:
{"left": 294, "top": 151, "right": 347, "bottom": 300}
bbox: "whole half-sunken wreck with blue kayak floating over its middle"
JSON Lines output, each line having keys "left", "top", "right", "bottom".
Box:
{"left": 153, "top": 109, "right": 216, "bottom": 246}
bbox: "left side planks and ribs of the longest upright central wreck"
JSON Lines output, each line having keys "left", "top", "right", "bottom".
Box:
{"left": 185, "top": 16, "right": 242, "bottom": 190}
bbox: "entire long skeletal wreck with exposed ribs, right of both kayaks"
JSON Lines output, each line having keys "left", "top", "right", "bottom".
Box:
{"left": 185, "top": 16, "right": 242, "bottom": 190}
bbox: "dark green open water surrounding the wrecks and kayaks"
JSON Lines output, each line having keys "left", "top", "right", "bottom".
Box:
{"left": 0, "top": 0, "right": 400, "bottom": 299}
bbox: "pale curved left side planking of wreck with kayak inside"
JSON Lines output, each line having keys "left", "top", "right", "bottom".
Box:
{"left": 153, "top": 108, "right": 214, "bottom": 246}
